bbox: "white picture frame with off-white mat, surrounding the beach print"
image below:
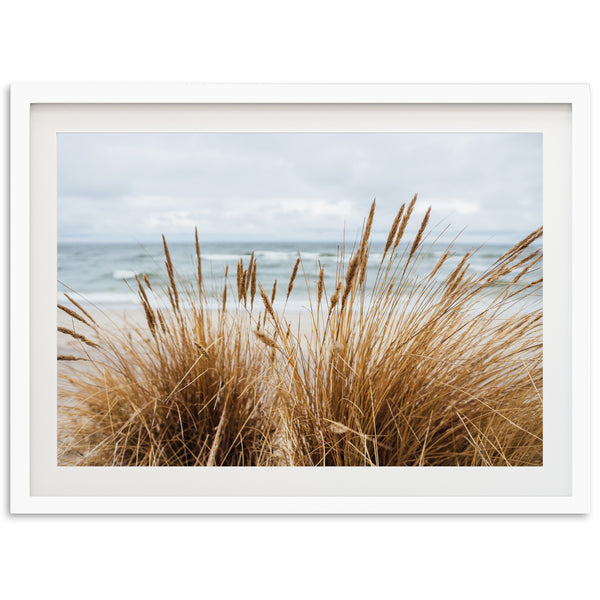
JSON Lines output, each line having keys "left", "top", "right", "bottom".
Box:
{"left": 10, "top": 84, "right": 591, "bottom": 513}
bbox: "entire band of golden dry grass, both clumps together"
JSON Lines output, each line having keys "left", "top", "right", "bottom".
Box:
{"left": 59, "top": 196, "right": 542, "bottom": 466}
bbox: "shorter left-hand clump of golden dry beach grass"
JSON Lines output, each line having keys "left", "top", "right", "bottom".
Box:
{"left": 59, "top": 232, "right": 273, "bottom": 466}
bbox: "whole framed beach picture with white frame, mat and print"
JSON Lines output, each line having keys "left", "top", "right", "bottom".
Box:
{"left": 10, "top": 84, "right": 590, "bottom": 513}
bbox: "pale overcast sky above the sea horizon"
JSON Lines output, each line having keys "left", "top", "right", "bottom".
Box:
{"left": 58, "top": 133, "right": 542, "bottom": 242}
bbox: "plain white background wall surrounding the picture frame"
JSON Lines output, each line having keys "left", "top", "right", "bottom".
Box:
{"left": 0, "top": 0, "right": 600, "bottom": 600}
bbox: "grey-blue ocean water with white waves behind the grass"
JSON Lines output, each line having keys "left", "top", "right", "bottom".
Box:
{"left": 57, "top": 240, "right": 541, "bottom": 310}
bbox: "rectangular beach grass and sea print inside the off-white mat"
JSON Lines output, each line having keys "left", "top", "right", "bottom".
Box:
{"left": 57, "top": 133, "right": 543, "bottom": 467}
